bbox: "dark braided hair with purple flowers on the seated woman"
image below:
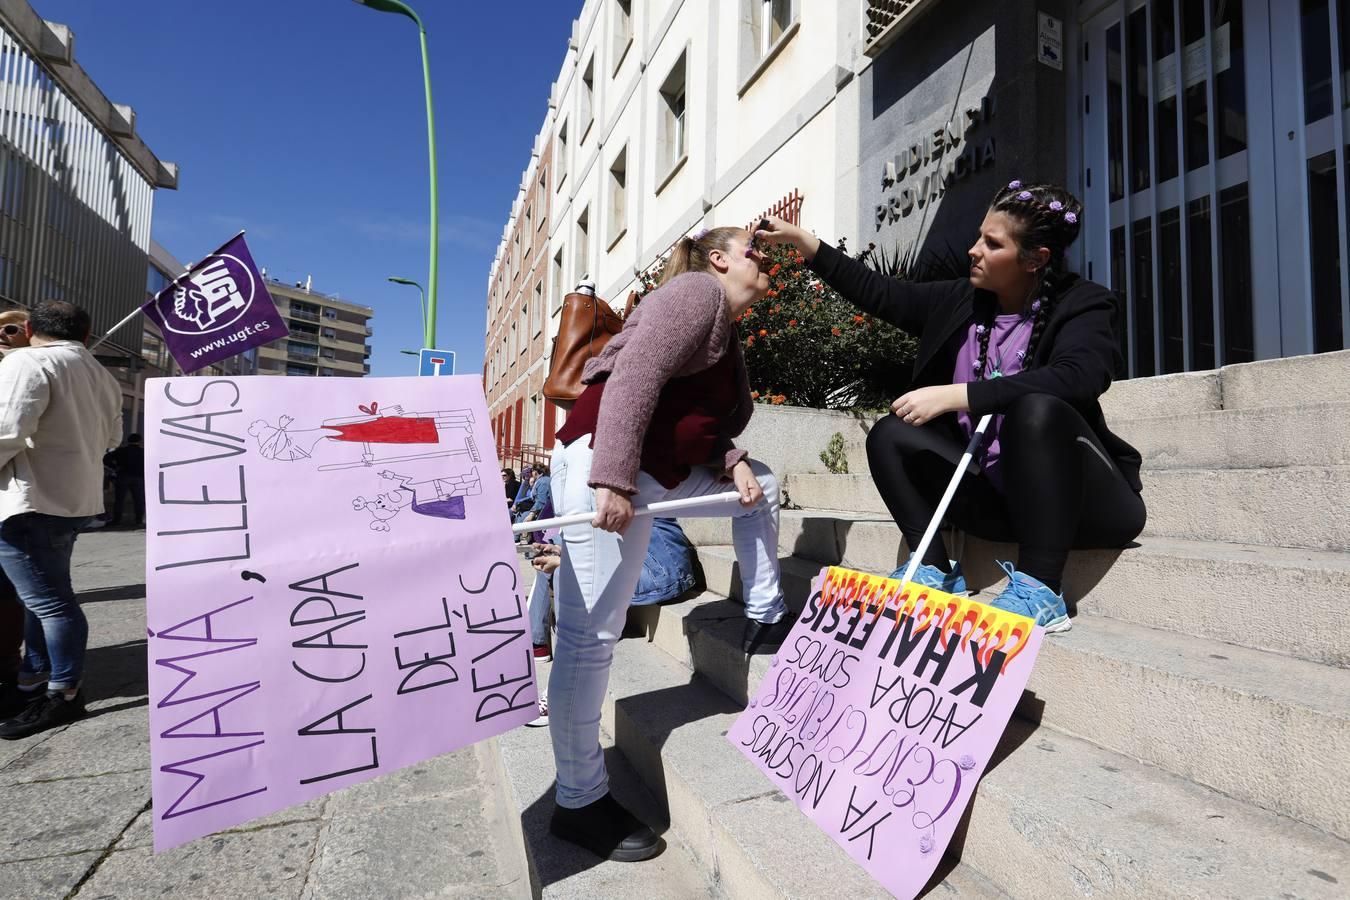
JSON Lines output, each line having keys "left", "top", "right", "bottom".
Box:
{"left": 975, "top": 181, "right": 1083, "bottom": 378}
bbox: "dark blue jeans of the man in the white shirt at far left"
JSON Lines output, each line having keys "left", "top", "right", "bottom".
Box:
{"left": 0, "top": 513, "right": 89, "bottom": 691}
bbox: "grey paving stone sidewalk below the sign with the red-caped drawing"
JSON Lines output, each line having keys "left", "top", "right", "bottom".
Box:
{"left": 0, "top": 530, "right": 531, "bottom": 900}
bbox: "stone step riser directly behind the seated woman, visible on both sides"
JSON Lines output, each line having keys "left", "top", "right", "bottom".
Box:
{"left": 783, "top": 466, "right": 1350, "bottom": 551}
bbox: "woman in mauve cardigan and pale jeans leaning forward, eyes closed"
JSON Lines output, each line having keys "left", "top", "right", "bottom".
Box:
{"left": 548, "top": 228, "right": 788, "bottom": 861}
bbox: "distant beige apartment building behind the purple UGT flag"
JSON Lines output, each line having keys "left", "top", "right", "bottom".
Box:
{"left": 258, "top": 278, "right": 375, "bottom": 378}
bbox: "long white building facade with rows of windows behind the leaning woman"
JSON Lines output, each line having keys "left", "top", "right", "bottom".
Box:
{"left": 485, "top": 0, "right": 871, "bottom": 456}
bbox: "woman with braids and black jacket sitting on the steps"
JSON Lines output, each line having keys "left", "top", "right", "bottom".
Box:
{"left": 756, "top": 181, "right": 1145, "bottom": 631}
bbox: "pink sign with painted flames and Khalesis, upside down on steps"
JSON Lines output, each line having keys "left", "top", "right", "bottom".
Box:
{"left": 726, "top": 567, "right": 1044, "bottom": 897}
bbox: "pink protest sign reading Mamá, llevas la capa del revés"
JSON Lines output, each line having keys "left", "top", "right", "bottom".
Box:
{"left": 146, "top": 376, "right": 537, "bottom": 850}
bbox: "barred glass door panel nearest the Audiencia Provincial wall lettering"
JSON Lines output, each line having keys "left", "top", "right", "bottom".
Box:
{"left": 1081, "top": 0, "right": 1258, "bottom": 376}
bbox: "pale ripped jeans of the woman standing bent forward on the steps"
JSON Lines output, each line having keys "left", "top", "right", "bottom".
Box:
{"left": 548, "top": 437, "right": 787, "bottom": 810}
